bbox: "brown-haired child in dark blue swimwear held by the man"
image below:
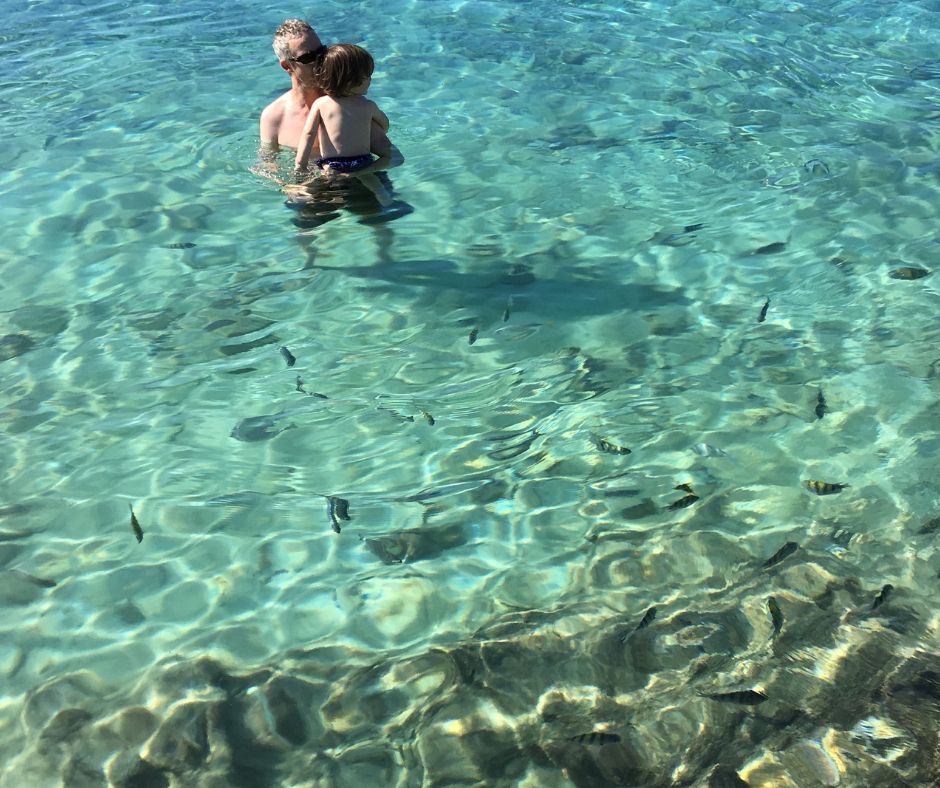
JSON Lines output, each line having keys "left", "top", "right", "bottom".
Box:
{"left": 294, "top": 44, "right": 392, "bottom": 207}
